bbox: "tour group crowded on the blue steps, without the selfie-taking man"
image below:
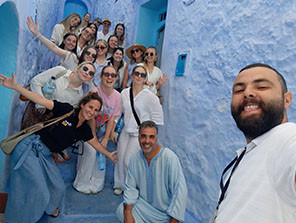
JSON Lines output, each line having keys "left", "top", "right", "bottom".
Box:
{"left": 0, "top": 13, "right": 187, "bottom": 223}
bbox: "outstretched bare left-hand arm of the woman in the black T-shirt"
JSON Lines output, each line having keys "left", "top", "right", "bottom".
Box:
{"left": 0, "top": 72, "right": 54, "bottom": 110}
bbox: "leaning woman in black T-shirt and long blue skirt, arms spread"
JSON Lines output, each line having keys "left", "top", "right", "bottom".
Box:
{"left": 0, "top": 72, "right": 117, "bottom": 222}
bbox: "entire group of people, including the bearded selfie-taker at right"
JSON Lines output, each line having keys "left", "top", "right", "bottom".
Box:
{"left": 0, "top": 9, "right": 296, "bottom": 223}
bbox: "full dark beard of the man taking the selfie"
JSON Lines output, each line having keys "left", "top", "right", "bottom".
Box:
{"left": 231, "top": 98, "right": 285, "bottom": 140}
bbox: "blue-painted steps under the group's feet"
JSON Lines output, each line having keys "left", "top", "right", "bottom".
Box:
{"left": 38, "top": 149, "right": 122, "bottom": 223}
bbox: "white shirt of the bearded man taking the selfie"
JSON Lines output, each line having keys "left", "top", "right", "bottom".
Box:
{"left": 215, "top": 123, "right": 296, "bottom": 223}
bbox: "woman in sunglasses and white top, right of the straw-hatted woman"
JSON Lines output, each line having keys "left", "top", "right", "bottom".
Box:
{"left": 140, "top": 46, "right": 167, "bottom": 94}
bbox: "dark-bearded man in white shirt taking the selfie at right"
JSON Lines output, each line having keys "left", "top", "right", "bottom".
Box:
{"left": 212, "top": 64, "right": 296, "bottom": 223}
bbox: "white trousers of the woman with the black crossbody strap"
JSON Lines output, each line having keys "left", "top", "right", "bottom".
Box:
{"left": 114, "top": 129, "right": 141, "bottom": 190}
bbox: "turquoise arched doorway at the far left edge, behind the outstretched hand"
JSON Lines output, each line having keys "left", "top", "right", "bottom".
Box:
{"left": 0, "top": 2, "right": 19, "bottom": 181}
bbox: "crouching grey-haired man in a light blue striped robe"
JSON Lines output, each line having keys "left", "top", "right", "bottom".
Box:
{"left": 117, "top": 121, "right": 187, "bottom": 223}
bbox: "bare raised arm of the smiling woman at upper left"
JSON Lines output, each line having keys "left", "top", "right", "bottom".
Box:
{"left": 26, "top": 16, "right": 67, "bottom": 59}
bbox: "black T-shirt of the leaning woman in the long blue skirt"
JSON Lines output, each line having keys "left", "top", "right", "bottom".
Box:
{"left": 36, "top": 101, "right": 93, "bottom": 152}
